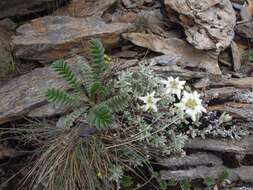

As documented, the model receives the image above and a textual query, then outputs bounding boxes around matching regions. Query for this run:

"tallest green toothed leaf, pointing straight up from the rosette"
[90,38,107,75]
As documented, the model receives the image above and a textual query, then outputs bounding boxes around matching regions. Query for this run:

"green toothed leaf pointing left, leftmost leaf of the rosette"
[46,88,77,105]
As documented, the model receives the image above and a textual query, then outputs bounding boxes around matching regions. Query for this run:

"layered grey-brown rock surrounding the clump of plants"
[0,0,253,190]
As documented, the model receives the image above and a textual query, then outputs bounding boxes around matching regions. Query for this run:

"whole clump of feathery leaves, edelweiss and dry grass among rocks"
[19,39,247,190]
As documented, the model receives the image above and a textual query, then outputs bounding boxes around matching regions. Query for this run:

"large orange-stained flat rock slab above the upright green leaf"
[12,16,133,62]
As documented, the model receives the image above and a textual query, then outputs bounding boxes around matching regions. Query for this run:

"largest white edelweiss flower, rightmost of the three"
[175,91,206,121]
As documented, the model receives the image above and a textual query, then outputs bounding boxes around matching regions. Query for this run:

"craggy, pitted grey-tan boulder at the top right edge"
[164,0,236,50]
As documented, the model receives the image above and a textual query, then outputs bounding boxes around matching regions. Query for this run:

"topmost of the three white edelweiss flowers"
[161,77,185,98]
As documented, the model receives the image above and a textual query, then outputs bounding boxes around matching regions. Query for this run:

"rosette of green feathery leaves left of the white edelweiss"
[46,39,128,130]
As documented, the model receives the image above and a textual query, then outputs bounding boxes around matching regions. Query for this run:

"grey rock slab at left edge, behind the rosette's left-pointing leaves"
[0,56,86,124]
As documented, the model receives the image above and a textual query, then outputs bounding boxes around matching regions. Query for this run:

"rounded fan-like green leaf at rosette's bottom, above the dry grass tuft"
[87,104,113,130]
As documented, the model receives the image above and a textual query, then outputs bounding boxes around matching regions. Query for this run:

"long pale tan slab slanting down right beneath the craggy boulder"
[123,33,221,75]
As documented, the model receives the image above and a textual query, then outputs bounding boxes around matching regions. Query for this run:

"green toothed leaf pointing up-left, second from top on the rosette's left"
[52,60,80,88]
